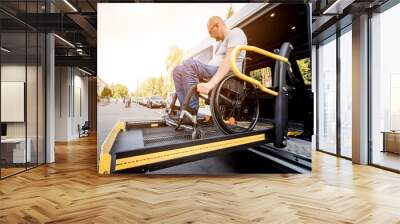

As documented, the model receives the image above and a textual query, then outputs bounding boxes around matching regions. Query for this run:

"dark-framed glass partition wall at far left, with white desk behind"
[0,1,46,178]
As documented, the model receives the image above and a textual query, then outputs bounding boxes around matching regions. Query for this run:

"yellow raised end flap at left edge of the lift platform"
[99,121,125,174]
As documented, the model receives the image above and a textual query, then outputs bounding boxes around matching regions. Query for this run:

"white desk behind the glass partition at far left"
[1,138,32,163]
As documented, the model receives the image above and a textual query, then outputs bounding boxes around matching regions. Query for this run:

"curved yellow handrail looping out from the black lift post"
[231,45,291,96]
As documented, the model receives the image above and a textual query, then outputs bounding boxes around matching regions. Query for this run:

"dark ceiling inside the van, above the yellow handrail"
[242,4,311,72]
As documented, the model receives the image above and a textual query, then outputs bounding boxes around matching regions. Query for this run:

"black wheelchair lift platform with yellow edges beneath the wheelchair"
[99,121,267,174]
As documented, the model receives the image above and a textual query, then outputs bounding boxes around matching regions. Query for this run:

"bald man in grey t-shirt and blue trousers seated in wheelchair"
[172,16,247,116]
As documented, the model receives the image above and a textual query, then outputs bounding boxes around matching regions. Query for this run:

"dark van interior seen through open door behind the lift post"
[238,4,313,140]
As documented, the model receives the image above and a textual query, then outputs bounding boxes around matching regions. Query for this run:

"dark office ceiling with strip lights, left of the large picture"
[0,0,103,74]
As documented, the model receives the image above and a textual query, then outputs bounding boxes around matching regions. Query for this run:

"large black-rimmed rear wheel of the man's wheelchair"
[210,75,259,134]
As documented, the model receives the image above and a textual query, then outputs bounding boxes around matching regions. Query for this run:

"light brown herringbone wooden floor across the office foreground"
[0,134,400,224]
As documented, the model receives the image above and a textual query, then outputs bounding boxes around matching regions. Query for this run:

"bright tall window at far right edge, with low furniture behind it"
[370,4,400,170]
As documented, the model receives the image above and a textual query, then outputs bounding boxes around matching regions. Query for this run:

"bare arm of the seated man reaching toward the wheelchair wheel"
[197,48,233,94]
